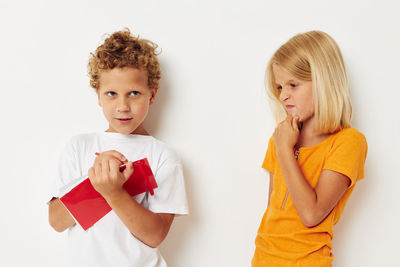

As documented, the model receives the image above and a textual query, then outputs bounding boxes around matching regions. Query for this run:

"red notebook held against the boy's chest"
[60,158,157,231]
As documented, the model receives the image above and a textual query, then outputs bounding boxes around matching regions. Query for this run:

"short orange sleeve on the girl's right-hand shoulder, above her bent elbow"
[323,129,368,188]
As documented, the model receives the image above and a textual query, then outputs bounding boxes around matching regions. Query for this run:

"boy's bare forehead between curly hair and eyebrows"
[100,67,148,86]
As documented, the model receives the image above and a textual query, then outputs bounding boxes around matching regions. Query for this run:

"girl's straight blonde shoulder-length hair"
[265,31,352,133]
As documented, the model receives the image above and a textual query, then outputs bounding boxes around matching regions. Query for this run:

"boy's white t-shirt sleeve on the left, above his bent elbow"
[50,138,82,199]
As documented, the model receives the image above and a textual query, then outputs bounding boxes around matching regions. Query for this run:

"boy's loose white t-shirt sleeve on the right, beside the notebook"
[144,149,189,215]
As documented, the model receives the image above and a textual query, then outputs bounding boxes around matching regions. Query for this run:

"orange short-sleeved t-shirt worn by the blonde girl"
[252,128,367,267]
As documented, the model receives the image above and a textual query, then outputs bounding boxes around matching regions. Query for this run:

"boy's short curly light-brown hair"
[88,28,161,90]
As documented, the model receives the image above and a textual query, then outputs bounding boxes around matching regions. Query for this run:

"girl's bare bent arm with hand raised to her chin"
[273,115,350,227]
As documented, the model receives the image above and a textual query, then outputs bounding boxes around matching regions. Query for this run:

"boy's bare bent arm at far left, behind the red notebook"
[49,198,75,232]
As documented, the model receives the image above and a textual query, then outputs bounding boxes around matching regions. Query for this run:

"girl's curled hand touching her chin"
[272,114,300,155]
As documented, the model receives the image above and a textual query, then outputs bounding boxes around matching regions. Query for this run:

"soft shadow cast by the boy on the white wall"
[145,62,196,266]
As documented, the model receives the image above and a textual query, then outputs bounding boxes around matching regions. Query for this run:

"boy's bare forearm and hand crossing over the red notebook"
[89,152,175,247]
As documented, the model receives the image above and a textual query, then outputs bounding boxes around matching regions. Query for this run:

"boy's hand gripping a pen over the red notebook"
[89,151,133,199]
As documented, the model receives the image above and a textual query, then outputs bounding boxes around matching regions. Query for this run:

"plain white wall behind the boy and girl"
[0,0,400,267]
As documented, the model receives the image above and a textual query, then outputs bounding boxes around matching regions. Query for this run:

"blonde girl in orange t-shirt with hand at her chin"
[252,31,367,267]
